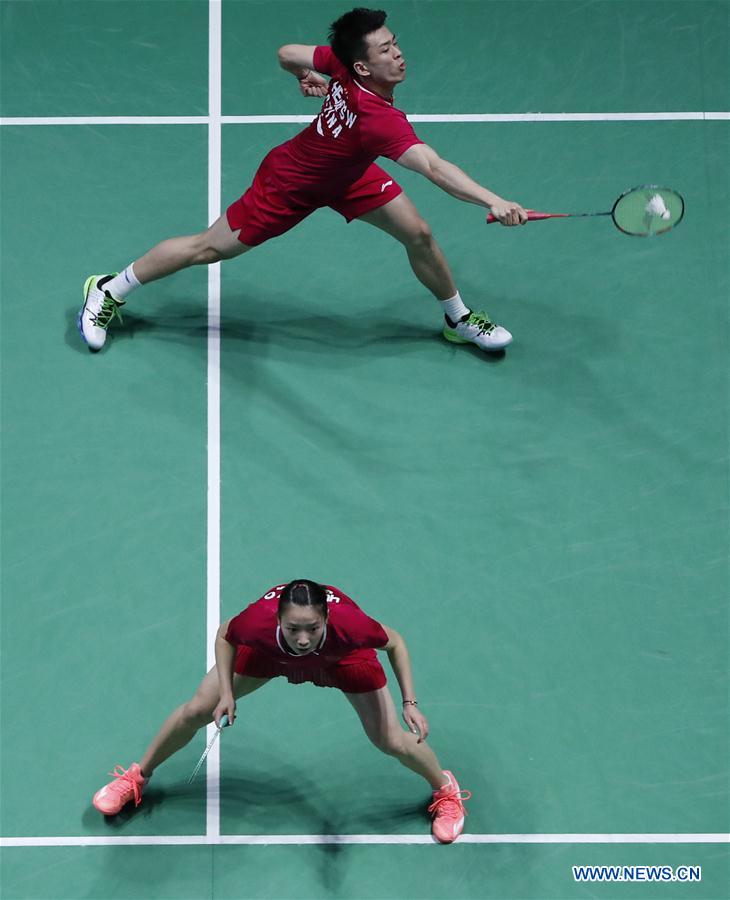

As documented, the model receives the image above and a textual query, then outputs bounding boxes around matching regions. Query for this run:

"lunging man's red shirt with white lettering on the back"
[264,47,423,206]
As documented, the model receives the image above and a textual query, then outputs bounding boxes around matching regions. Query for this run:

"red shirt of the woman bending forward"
[226,584,388,669]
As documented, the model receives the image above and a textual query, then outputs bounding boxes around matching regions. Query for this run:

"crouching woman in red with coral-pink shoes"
[92,579,471,843]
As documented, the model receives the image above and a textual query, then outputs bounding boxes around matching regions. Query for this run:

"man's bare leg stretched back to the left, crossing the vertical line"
[132,215,251,284]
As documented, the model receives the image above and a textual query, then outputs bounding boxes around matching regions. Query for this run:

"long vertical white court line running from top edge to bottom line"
[205,0,221,840]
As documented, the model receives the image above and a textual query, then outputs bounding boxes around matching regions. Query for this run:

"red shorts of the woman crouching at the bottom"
[234,645,388,694]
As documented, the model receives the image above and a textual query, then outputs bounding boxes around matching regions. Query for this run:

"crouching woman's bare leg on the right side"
[345,687,447,791]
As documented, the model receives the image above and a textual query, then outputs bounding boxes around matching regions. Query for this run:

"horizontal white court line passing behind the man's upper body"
[0,111,730,125]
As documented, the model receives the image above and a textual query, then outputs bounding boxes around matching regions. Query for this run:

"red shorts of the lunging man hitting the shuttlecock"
[226,156,403,247]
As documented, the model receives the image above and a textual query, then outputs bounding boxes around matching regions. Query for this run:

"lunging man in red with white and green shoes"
[78,8,527,351]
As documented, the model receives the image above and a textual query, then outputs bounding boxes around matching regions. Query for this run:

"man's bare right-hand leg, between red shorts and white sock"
[356,194,456,300]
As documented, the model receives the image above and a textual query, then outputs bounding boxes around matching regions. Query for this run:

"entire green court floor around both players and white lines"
[0,0,730,900]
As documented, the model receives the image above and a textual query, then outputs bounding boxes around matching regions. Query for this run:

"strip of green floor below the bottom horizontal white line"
[3,844,728,900]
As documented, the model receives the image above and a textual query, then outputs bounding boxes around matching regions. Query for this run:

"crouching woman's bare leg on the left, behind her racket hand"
[140,666,268,778]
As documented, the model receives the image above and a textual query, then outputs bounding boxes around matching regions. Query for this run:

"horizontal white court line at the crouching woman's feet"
[0,832,730,847]
